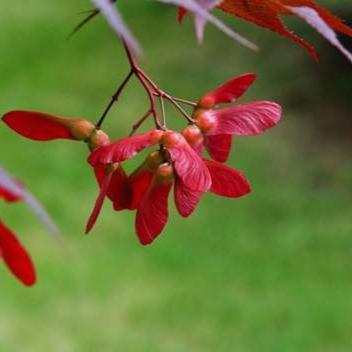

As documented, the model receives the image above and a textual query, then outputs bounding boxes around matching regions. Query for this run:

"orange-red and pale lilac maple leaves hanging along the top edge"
[91,0,352,63]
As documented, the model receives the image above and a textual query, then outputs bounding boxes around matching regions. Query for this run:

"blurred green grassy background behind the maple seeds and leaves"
[0,0,352,352]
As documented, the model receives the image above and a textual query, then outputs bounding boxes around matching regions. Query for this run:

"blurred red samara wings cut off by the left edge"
[0,182,36,286]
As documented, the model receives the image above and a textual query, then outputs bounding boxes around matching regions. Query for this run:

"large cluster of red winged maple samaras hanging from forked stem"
[3,74,281,244]
